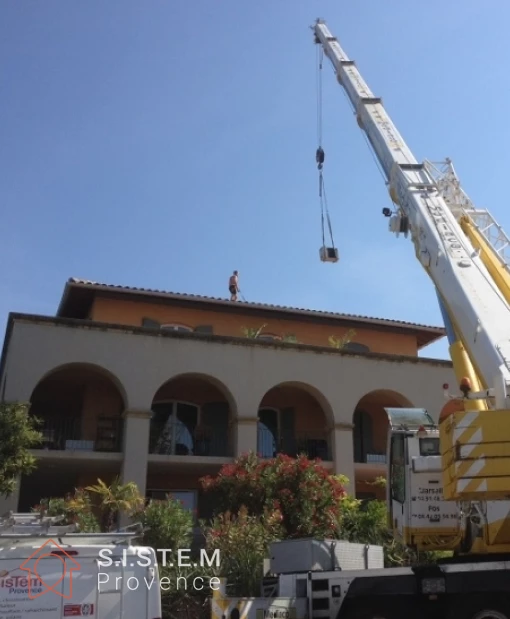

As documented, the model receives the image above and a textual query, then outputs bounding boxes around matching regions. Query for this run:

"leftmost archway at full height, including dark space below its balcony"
[18,363,125,511]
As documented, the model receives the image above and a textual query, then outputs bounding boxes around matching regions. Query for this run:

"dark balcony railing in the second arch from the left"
[149,421,231,457]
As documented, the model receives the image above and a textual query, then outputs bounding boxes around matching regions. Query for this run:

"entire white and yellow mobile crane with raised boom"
[213,20,510,619]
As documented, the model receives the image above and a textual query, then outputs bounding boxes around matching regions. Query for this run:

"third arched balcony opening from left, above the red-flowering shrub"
[257,383,333,460]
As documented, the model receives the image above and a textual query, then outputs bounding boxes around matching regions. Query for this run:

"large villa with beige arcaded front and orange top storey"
[0,279,454,517]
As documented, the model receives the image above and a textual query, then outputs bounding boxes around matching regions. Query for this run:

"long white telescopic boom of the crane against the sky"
[313,20,510,409]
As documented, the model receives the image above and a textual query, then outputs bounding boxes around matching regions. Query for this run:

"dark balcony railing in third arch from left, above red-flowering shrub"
[257,426,331,460]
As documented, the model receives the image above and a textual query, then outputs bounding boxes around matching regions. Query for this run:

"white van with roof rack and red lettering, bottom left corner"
[0,514,161,619]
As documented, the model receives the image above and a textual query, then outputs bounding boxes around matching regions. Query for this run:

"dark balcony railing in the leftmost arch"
[37,417,123,452]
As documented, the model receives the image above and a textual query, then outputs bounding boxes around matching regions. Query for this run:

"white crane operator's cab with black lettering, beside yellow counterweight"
[385,408,461,550]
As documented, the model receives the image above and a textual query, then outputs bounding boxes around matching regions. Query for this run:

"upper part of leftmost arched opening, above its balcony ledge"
[30,364,125,452]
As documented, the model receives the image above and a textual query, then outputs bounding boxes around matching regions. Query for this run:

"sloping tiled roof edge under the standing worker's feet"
[59,277,445,339]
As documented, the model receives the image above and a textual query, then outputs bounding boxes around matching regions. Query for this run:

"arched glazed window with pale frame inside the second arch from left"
[151,402,199,456]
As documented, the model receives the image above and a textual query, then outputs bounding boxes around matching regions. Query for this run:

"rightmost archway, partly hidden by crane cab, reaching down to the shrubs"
[353,389,413,499]
